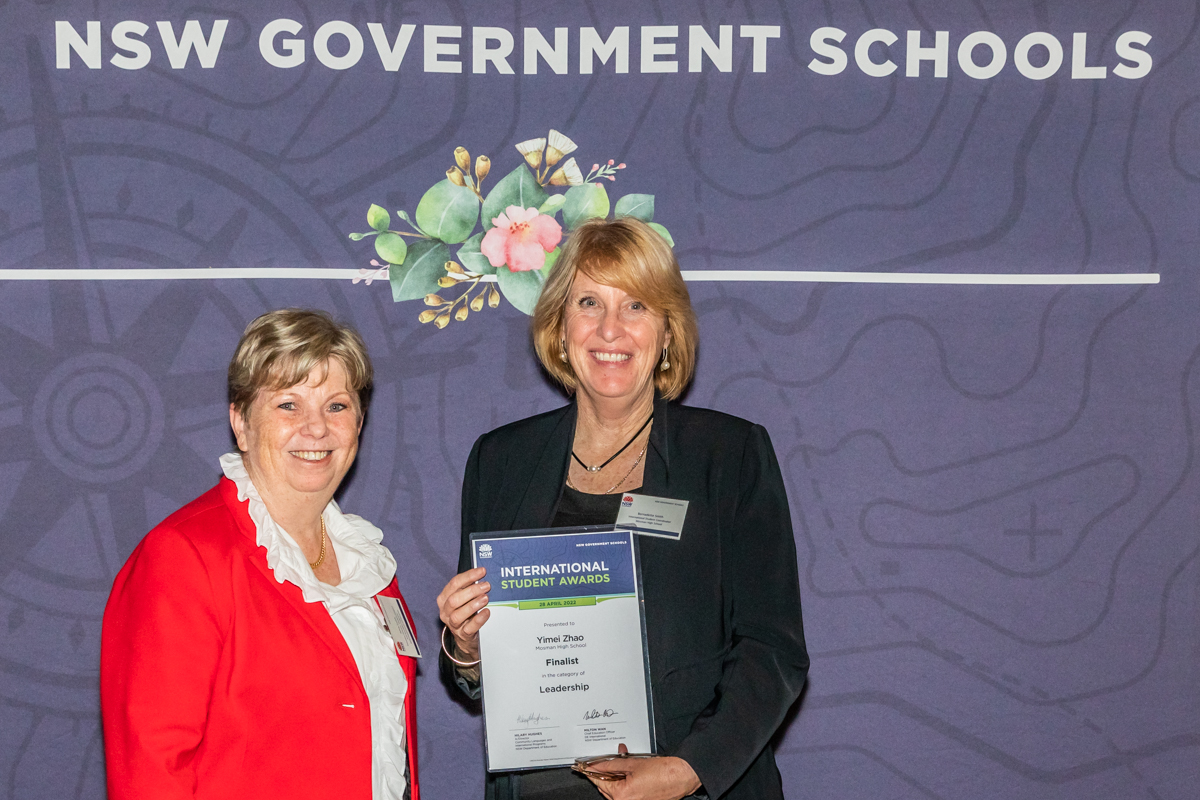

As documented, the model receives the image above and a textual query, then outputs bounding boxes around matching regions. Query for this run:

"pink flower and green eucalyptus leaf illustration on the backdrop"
[350,130,674,329]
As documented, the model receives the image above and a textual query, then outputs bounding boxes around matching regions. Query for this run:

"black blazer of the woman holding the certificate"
[443,398,809,800]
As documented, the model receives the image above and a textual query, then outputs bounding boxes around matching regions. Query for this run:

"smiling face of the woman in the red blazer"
[229,359,362,505]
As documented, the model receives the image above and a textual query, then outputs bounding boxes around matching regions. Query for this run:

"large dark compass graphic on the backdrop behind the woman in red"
[0,31,451,798]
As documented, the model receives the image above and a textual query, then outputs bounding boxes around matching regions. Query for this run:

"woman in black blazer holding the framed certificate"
[438,218,809,800]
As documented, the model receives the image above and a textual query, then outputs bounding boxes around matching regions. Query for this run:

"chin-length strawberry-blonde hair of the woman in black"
[532,217,698,399]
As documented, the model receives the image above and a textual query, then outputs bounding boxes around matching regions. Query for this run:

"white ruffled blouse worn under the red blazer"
[221,453,408,800]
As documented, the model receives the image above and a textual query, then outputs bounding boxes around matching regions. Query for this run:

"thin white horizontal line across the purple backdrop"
[0,266,1159,285]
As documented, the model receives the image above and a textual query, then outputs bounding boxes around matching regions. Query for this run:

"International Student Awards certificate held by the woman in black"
[470,525,654,772]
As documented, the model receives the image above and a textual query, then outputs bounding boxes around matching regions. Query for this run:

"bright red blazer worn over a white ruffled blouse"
[100,479,420,800]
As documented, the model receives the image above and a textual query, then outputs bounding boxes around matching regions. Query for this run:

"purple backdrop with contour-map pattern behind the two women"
[0,0,1200,800]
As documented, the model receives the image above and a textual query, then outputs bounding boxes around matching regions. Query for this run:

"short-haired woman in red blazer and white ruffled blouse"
[100,309,420,800]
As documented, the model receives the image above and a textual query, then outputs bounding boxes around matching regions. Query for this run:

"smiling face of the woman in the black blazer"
[563,272,671,403]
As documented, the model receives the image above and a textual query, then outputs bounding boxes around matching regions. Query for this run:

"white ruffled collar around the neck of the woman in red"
[221,452,396,613]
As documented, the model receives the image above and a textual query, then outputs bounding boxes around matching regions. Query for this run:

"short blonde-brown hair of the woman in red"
[229,308,374,420]
